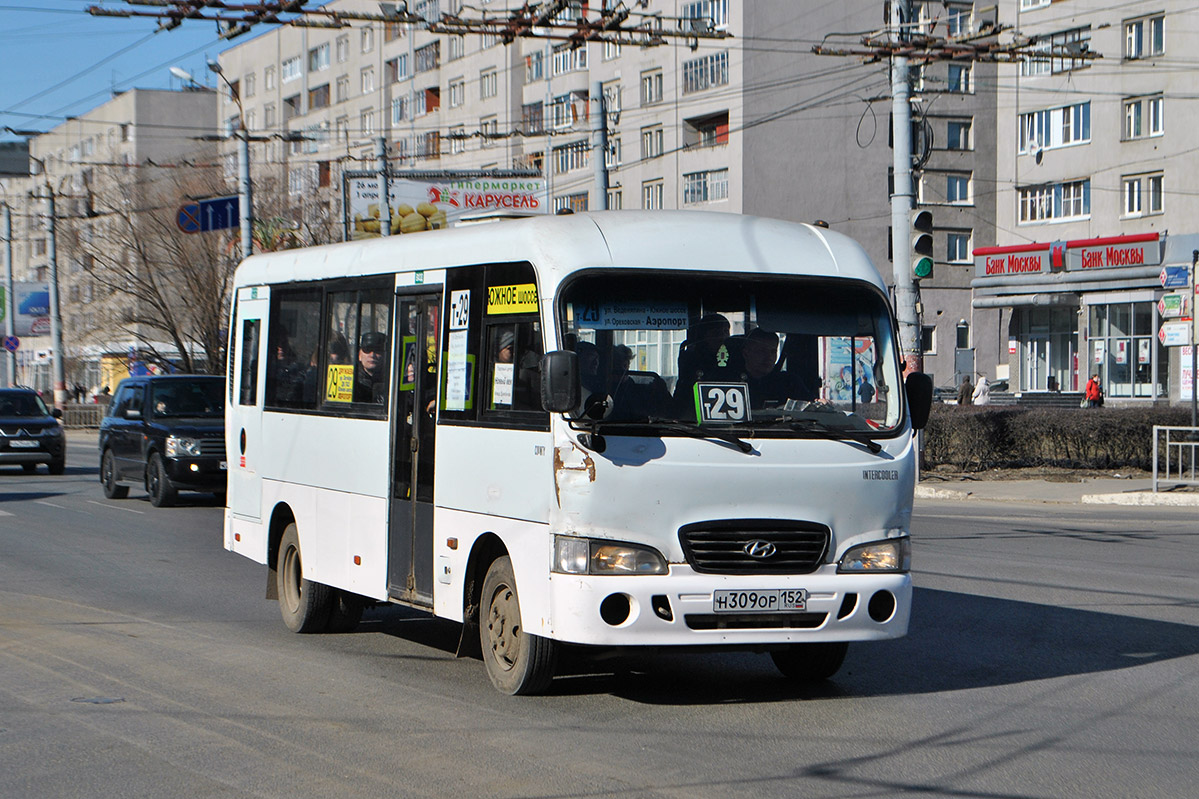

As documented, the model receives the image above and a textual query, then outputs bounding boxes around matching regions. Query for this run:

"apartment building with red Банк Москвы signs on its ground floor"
[972,0,1199,402]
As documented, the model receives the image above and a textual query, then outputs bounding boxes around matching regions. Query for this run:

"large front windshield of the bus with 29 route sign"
[560,271,902,435]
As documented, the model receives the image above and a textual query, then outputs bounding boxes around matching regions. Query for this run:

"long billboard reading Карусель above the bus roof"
[343,174,547,241]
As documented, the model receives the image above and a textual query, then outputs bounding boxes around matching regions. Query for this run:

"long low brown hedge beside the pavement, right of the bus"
[924,404,1191,471]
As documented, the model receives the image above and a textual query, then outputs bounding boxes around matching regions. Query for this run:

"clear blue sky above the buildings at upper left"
[0,0,252,140]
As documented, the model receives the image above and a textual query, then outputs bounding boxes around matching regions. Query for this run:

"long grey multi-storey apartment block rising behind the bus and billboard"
[219,0,1006,384]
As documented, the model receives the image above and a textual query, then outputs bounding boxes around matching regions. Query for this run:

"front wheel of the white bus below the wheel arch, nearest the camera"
[478,555,558,696]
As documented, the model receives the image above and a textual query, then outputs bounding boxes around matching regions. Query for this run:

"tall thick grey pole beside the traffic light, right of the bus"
[887,0,924,373]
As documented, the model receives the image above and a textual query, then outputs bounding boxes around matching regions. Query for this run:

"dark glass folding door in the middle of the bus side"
[387,294,441,607]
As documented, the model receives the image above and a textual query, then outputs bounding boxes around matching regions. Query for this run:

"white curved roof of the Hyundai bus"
[235,211,886,295]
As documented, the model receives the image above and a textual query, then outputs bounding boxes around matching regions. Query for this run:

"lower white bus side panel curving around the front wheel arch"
[433,507,552,636]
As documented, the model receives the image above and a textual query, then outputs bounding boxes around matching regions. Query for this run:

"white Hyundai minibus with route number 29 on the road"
[224,211,932,693]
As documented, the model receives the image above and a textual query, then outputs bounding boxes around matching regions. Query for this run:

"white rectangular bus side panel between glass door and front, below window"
[433,425,555,520]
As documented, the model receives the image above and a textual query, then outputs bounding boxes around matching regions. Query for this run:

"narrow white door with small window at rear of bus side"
[225,286,271,522]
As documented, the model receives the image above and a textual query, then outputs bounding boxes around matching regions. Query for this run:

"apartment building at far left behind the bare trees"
[17,89,217,389]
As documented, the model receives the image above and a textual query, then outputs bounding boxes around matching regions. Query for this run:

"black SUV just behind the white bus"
[100,374,227,507]
